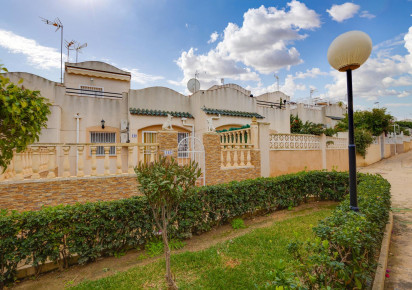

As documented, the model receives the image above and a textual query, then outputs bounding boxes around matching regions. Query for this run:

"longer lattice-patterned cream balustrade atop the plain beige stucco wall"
[269,134,321,150]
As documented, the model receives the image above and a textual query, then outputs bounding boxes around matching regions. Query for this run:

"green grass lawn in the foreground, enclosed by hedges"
[74,206,334,290]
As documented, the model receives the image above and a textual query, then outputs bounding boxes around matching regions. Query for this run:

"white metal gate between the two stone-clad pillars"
[177,137,206,185]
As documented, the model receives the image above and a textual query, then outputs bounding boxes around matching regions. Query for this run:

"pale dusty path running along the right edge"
[359,151,412,289]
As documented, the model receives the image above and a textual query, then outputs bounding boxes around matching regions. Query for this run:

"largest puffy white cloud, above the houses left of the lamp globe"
[176,0,321,88]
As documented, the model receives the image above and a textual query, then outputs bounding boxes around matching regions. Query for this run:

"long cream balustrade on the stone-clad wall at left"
[0,143,158,181]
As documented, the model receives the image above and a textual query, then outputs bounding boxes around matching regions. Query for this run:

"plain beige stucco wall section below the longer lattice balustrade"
[269,150,324,176]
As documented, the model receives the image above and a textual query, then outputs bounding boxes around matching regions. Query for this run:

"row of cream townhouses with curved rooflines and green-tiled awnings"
[7,61,290,147]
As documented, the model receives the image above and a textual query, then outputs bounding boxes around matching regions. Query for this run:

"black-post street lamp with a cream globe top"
[328,31,372,211]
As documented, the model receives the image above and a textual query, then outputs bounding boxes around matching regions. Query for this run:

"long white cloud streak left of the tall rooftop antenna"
[0,29,62,69]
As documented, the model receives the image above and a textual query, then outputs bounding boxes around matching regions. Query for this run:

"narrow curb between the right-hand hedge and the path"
[372,212,393,290]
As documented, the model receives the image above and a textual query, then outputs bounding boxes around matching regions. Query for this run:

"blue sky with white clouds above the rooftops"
[0,0,412,119]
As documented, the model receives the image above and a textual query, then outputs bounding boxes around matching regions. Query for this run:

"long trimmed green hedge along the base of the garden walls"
[0,171,348,286]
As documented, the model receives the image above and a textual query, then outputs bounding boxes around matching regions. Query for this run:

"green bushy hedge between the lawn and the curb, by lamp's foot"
[289,175,391,289]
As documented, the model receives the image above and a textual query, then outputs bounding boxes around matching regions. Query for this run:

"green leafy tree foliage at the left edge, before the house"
[0,65,50,170]
